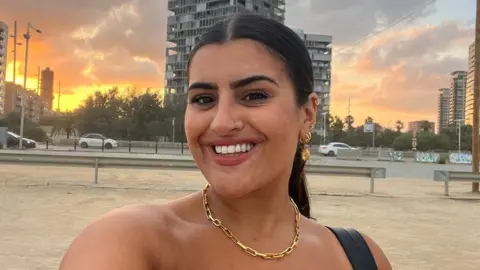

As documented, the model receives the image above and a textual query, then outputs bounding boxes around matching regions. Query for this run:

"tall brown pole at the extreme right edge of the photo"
[472,0,480,193]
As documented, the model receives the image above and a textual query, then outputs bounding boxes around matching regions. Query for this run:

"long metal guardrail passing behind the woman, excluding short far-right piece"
[0,150,386,193]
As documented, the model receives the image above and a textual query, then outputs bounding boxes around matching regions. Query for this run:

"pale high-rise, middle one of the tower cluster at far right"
[448,70,467,125]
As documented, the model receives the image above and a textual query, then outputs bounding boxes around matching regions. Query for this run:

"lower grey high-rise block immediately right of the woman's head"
[295,30,332,135]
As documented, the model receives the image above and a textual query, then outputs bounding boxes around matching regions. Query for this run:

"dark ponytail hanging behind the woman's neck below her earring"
[288,143,312,218]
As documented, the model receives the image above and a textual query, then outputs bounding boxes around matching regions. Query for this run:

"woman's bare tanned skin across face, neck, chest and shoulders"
[60,40,391,270]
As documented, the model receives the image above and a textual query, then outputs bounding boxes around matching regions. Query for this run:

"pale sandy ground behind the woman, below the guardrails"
[0,165,480,270]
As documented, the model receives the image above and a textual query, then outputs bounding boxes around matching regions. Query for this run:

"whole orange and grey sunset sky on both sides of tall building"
[0,0,476,126]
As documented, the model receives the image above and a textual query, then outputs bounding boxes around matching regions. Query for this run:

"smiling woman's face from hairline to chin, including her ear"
[185,40,316,197]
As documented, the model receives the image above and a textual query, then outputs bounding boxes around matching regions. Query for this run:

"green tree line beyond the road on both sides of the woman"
[0,88,472,151]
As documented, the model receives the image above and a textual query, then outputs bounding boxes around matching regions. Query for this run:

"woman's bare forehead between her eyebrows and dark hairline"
[189,39,287,82]
